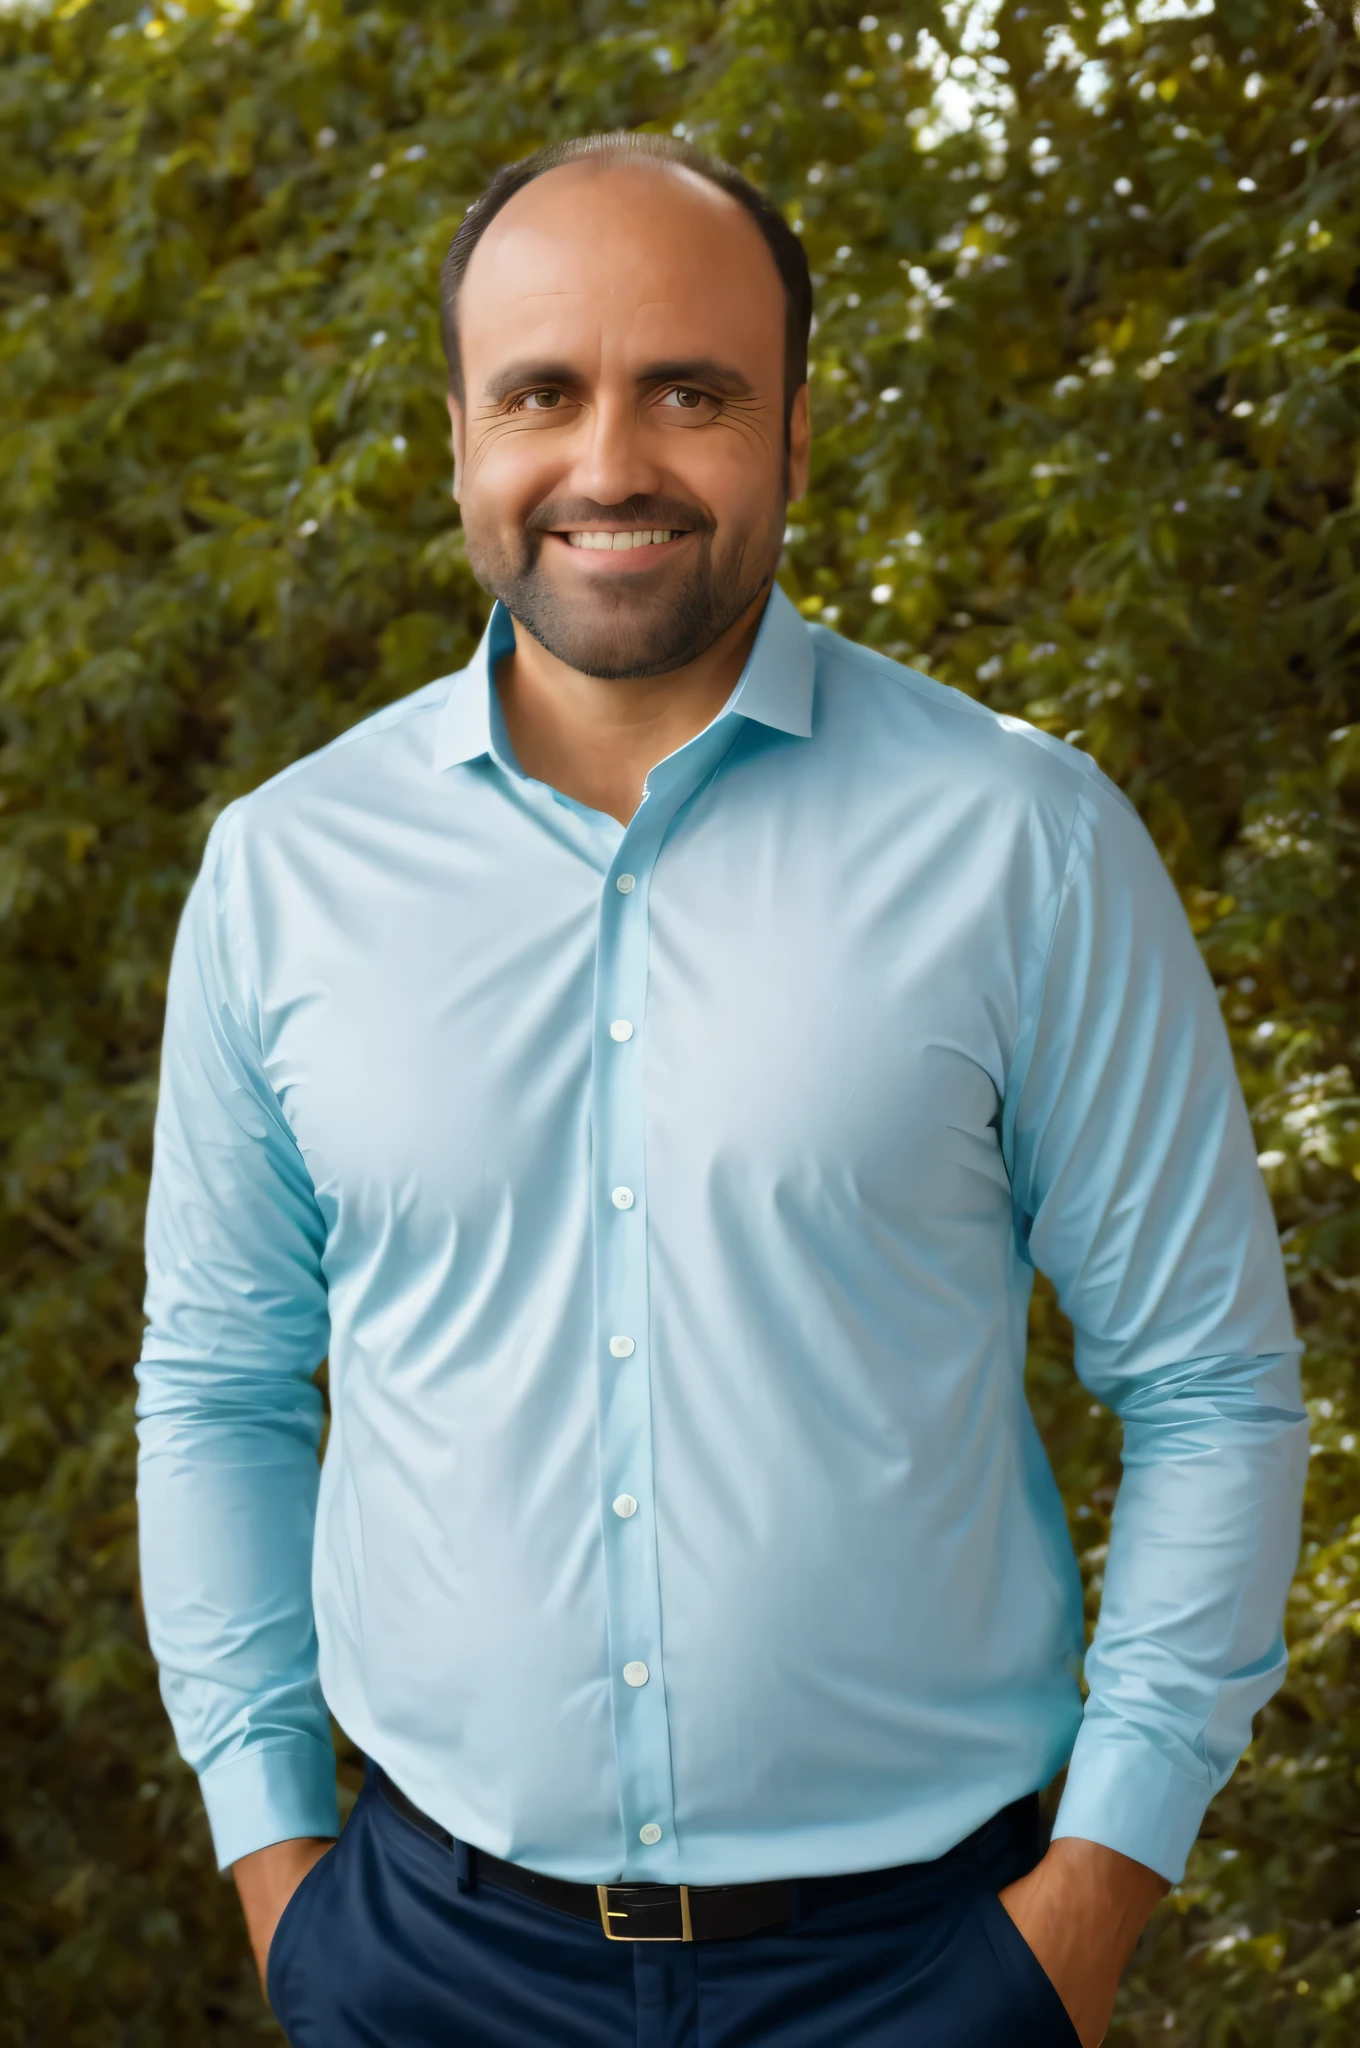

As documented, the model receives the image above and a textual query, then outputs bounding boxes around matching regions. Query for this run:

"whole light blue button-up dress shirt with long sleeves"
[137,592,1305,1884]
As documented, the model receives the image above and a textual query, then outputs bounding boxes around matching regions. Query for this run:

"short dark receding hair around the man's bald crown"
[438,129,813,420]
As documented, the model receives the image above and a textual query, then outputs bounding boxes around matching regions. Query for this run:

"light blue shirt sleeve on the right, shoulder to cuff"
[1004,776,1307,1880]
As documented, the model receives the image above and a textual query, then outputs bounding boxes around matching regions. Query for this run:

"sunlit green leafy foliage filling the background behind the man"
[0,0,1360,2048]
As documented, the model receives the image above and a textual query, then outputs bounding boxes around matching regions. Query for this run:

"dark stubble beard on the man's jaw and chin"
[467,512,776,682]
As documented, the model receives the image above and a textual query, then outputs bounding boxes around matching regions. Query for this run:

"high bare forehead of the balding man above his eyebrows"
[459,162,784,381]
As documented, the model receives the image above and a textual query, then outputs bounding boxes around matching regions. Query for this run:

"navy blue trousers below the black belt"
[268,1774,1077,2048]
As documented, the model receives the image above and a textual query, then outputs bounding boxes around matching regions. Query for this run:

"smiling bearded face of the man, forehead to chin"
[449,164,807,676]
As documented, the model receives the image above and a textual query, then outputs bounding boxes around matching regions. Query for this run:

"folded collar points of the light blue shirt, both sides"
[434,584,817,768]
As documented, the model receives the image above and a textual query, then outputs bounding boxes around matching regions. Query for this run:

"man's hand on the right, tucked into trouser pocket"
[1002,1837,1170,2048]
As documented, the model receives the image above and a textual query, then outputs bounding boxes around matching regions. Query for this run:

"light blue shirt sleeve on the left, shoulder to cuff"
[137,813,336,1868]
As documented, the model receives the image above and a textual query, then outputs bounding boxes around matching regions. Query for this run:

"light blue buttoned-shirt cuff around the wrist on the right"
[1053,1718,1213,1884]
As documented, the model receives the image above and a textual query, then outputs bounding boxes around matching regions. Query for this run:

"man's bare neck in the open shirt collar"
[496,586,770,825]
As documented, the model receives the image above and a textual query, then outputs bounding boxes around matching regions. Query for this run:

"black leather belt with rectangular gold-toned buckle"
[375,1767,1038,1942]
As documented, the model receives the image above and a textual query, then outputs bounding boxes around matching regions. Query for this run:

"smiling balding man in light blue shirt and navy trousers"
[139,137,1305,2048]
